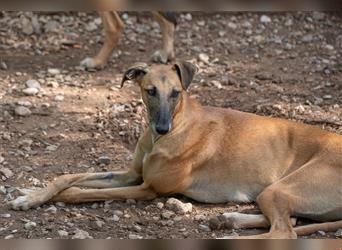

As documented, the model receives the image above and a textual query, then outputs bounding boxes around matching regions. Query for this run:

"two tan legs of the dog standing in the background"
[81,11,177,69]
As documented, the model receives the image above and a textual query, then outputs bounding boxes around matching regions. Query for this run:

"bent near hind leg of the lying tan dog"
[231,160,342,238]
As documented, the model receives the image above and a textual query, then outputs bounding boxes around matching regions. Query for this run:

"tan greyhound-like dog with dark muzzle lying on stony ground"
[10,62,342,238]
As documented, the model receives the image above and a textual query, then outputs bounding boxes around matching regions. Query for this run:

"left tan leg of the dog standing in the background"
[81,11,124,68]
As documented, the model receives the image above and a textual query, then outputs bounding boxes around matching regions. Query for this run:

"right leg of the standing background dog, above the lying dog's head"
[152,12,176,63]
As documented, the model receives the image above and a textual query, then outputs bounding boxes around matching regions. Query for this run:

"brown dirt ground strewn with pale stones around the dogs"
[0,12,342,239]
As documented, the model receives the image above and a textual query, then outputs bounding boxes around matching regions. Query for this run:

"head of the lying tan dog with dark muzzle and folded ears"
[121,62,197,135]
